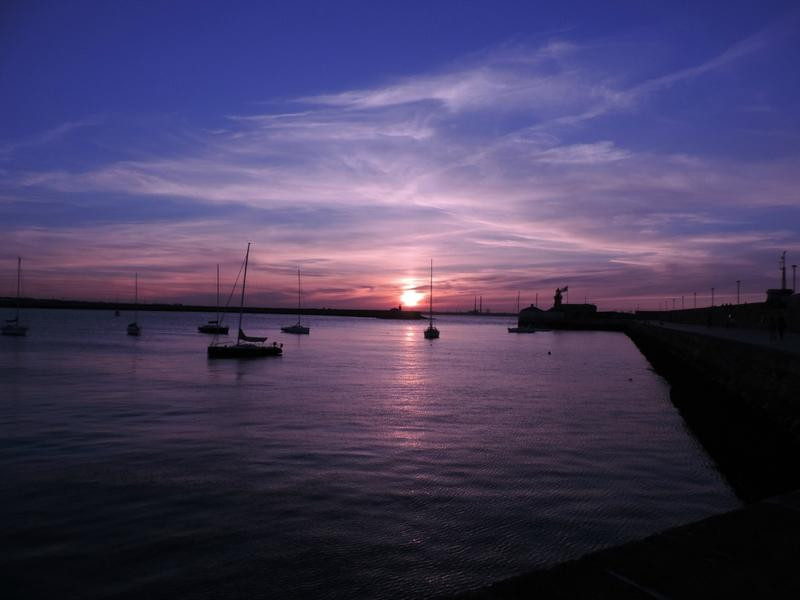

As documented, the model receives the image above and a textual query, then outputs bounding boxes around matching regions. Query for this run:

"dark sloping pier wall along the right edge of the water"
[625,322,800,502]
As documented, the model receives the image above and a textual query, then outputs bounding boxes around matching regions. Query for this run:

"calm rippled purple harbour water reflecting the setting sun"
[0,310,739,598]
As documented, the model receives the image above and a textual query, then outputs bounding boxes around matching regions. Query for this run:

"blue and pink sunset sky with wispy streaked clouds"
[0,0,800,312]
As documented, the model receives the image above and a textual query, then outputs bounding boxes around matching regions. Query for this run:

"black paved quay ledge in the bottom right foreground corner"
[457,491,800,600]
